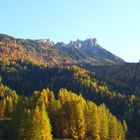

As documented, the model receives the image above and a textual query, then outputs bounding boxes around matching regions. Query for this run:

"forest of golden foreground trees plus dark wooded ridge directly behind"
[0,62,140,140]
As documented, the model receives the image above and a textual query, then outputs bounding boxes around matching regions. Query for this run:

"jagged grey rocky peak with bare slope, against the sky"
[54,38,124,65]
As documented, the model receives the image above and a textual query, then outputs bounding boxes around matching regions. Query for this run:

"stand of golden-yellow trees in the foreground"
[0,84,127,140]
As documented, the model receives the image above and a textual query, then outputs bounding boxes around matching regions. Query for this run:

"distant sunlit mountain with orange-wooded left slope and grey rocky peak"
[0,34,124,66]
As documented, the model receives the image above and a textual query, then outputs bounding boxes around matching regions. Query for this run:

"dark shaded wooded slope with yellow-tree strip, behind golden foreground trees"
[0,62,140,140]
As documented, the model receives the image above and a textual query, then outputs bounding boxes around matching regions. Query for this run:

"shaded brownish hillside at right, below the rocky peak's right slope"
[92,63,140,97]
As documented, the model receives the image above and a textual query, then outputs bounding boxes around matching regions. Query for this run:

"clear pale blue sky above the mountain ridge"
[0,0,140,62]
